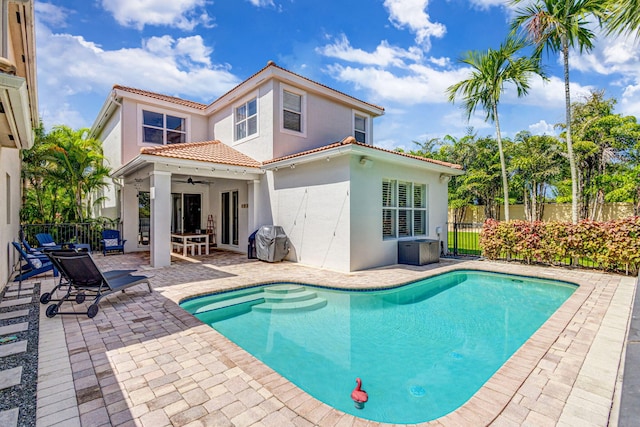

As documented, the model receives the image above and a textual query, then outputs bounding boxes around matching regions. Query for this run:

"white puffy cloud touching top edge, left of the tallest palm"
[384,0,447,50]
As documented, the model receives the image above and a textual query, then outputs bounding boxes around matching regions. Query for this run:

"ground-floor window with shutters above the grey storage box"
[380,178,429,240]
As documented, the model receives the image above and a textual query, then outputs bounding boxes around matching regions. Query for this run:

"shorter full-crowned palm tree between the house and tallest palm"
[447,37,543,221]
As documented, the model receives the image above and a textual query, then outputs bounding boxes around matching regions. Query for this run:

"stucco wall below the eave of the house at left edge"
[0,147,22,290]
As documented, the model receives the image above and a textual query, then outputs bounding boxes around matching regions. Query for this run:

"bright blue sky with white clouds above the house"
[35,0,640,150]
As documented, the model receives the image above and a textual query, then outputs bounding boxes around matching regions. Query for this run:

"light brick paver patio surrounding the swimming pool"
[31,251,635,427]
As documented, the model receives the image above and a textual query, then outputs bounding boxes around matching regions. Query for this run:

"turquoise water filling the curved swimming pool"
[181,271,577,424]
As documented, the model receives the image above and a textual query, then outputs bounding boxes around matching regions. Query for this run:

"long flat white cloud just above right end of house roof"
[316,34,422,67]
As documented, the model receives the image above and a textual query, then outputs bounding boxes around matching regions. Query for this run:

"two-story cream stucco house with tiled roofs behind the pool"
[92,61,462,271]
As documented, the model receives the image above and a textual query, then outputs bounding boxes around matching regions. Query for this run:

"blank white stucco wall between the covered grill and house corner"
[271,157,351,271]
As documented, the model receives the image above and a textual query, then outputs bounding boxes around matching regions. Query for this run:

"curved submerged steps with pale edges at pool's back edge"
[252,284,327,311]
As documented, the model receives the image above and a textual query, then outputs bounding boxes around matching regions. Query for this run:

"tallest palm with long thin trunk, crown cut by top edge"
[512,0,604,223]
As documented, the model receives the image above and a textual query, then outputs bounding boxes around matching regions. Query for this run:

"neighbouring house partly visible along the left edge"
[0,0,39,290]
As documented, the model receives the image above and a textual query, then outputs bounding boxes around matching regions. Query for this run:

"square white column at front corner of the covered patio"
[149,171,171,267]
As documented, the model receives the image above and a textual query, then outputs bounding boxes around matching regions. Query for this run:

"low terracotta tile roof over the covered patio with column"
[140,140,261,168]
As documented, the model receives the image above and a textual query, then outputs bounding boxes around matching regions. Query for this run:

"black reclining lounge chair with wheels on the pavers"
[46,251,151,318]
